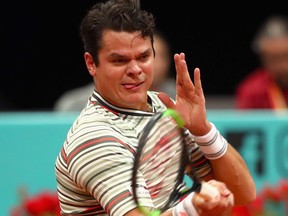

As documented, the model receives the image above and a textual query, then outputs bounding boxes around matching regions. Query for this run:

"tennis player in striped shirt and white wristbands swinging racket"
[55,0,256,216]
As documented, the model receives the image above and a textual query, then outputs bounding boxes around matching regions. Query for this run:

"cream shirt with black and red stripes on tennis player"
[55,91,211,216]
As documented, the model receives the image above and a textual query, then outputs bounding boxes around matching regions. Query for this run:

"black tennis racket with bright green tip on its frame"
[132,109,219,216]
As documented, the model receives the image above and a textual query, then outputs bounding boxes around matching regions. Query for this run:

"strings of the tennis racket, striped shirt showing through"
[140,120,184,206]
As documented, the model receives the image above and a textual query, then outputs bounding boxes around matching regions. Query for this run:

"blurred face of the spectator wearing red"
[260,37,288,88]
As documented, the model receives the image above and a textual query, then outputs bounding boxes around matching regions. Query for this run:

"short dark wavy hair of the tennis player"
[80,0,155,66]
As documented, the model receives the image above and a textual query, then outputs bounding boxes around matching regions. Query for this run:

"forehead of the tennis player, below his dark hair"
[102,30,151,51]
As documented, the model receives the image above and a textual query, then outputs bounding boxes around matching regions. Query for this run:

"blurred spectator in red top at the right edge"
[235,16,288,110]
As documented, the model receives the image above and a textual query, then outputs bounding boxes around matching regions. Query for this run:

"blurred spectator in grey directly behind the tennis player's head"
[54,31,176,111]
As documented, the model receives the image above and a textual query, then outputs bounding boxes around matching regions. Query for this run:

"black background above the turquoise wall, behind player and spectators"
[0,0,287,111]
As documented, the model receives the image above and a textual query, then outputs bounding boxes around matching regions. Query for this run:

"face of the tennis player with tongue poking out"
[94,31,154,110]
